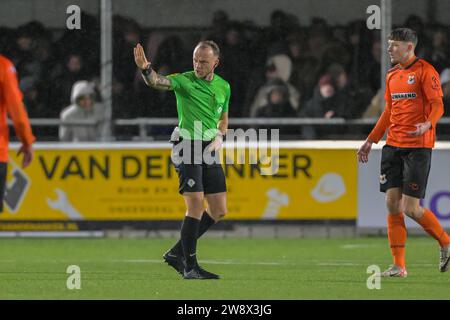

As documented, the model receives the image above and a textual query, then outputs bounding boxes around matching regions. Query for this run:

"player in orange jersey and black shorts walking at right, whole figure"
[358,28,450,277]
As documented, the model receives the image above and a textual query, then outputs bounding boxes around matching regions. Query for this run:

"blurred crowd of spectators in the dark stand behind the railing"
[0,10,450,138]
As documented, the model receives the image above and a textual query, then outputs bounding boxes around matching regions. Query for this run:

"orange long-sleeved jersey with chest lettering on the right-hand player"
[369,57,443,148]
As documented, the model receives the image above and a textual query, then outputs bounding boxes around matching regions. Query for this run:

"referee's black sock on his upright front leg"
[181,216,200,270]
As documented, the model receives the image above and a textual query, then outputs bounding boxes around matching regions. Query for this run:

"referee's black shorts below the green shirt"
[172,140,227,194]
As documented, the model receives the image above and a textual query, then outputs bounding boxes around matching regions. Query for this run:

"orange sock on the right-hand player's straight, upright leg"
[387,213,407,268]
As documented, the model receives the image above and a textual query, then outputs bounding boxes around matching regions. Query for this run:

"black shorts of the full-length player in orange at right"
[380,145,431,199]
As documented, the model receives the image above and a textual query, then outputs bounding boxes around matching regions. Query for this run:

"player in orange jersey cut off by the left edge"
[0,54,35,212]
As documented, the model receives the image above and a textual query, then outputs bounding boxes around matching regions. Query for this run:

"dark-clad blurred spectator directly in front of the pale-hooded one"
[256,82,296,118]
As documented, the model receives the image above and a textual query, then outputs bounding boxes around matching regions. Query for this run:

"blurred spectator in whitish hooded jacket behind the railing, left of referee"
[59,81,107,142]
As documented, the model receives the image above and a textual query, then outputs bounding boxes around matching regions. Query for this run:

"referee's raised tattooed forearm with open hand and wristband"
[134,43,172,90]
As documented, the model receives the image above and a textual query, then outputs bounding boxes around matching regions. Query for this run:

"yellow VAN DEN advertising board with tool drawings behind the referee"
[0,144,357,226]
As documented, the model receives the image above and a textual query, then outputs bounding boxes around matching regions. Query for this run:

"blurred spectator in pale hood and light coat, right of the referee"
[250,54,300,117]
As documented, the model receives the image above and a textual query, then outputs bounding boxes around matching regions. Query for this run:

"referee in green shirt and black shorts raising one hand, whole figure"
[134,41,231,279]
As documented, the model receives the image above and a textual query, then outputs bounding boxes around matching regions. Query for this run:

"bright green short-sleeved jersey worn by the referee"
[168,71,231,140]
